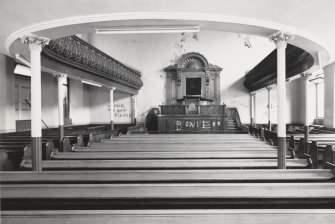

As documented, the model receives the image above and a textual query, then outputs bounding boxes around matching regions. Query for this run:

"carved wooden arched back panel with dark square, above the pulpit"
[164,52,222,105]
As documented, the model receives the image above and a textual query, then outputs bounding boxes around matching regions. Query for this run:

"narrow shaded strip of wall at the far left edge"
[0,54,16,133]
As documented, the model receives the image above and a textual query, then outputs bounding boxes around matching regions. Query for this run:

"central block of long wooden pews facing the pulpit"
[0,134,335,224]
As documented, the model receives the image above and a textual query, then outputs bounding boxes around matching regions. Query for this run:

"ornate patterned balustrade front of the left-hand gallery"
[43,36,143,89]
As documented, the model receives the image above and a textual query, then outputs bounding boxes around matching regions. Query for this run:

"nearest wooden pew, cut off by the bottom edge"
[1,209,335,224]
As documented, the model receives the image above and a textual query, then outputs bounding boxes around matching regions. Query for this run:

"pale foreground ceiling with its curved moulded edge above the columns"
[0,0,335,66]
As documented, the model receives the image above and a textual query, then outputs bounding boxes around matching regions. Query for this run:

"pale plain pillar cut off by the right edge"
[323,62,335,128]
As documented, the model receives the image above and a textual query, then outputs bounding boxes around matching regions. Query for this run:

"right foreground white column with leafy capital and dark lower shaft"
[270,31,294,169]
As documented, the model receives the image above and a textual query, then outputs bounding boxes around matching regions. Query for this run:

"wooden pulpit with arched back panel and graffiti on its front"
[158,53,226,133]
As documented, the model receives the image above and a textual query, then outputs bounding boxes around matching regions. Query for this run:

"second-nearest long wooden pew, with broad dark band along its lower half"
[1,182,335,210]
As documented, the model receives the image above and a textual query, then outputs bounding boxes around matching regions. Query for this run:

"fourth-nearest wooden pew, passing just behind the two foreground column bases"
[21,159,309,170]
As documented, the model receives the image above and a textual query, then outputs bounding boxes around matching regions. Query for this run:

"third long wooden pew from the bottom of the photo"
[0,169,335,184]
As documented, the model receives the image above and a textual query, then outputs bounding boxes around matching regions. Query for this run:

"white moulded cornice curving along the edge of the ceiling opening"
[4,11,326,61]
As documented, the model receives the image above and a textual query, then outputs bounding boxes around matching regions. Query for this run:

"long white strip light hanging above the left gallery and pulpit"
[96,25,200,34]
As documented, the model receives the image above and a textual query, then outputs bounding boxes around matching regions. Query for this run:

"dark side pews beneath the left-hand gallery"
[0,125,118,170]
